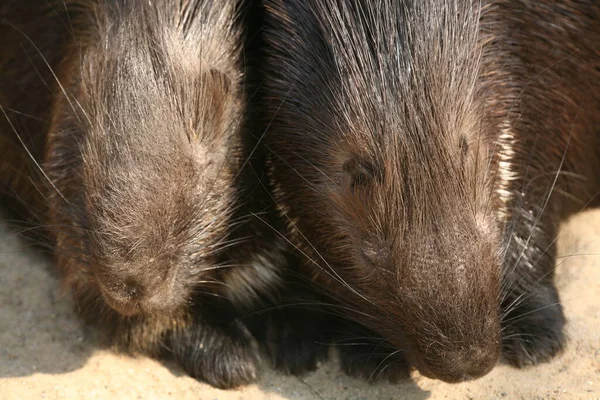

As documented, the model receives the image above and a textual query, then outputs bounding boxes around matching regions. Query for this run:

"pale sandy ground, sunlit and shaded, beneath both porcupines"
[0,211,600,400]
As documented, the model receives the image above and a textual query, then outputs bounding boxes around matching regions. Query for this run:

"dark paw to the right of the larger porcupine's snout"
[502,286,566,368]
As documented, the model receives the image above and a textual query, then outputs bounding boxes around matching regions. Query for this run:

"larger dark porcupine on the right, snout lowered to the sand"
[263,0,600,382]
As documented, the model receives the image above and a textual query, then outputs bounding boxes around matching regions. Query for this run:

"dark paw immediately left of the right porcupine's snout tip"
[338,343,410,383]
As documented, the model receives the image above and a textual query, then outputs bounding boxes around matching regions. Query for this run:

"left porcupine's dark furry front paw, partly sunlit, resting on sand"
[171,322,260,389]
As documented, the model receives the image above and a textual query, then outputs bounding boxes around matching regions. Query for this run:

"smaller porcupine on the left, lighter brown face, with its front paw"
[0,0,284,388]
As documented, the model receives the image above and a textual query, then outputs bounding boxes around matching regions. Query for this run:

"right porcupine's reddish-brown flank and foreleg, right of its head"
[481,0,600,367]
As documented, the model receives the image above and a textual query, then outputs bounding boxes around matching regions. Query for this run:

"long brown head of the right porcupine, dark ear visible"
[267,0,500,382]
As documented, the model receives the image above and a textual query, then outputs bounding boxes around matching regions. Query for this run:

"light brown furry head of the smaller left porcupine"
[45,0,240,316]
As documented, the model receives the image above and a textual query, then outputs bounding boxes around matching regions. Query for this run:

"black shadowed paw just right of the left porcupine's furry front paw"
[265,310,329,375]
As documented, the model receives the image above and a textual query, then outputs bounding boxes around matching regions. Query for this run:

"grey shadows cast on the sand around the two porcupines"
[0,211,429,400]
